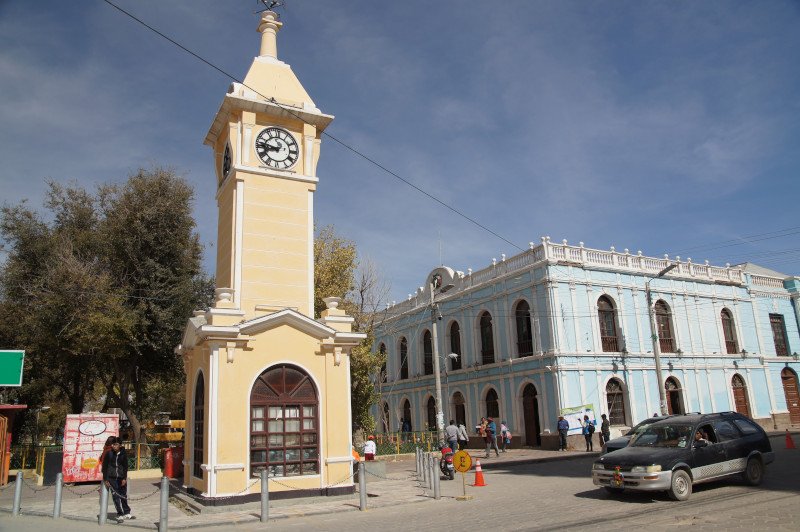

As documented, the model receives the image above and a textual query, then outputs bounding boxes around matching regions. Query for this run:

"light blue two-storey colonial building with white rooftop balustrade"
[374,237,800,448]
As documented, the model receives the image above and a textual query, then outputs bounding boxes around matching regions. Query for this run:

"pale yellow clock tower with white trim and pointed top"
[176,10,365,500]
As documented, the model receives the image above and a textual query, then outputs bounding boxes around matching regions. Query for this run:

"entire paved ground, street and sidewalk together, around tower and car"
[0,435,800,532]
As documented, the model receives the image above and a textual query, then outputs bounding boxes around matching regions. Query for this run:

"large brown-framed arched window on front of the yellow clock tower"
[250,364,319,477]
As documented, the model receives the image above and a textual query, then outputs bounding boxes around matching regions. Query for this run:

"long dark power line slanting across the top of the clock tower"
[103,0,524,251]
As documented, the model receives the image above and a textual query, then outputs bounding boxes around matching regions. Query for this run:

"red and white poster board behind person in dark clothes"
[61,412,119,482]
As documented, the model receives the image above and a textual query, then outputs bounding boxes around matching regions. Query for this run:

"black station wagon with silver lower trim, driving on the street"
[592,412,775,501]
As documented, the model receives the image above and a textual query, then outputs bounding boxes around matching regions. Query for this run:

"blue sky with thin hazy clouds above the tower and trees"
[0,0,800,301]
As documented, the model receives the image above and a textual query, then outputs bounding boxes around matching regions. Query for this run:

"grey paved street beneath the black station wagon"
[0,437,800,532]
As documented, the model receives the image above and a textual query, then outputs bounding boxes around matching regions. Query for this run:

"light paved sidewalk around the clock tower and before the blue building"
[0,449,597,530]
